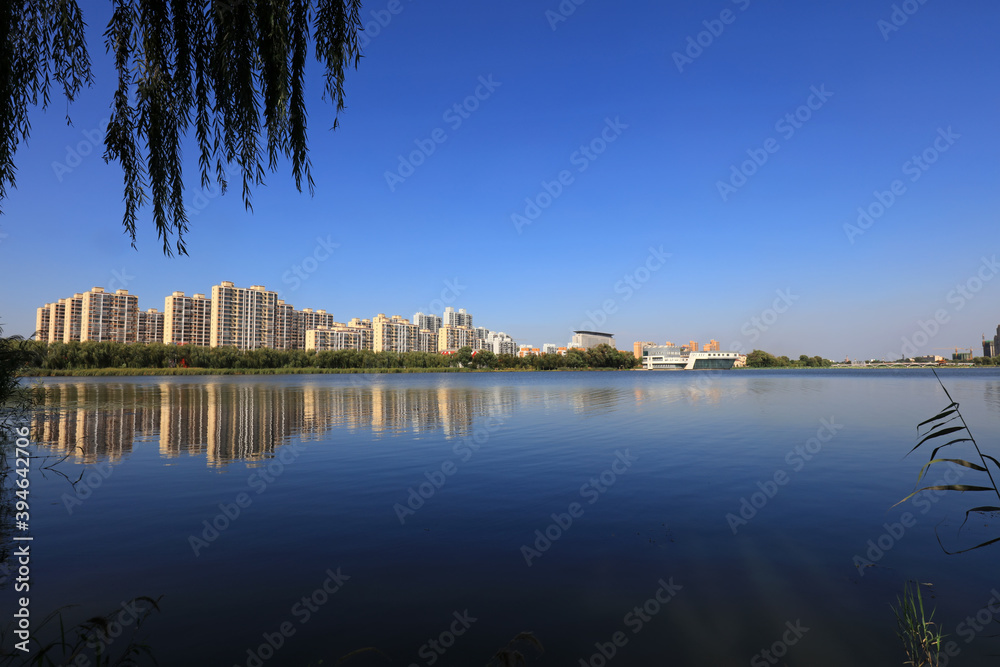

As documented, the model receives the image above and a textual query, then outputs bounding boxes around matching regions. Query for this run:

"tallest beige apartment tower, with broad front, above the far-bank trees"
[209,281,278,350]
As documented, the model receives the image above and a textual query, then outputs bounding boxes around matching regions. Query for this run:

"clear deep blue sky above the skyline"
[0,0,1000,359]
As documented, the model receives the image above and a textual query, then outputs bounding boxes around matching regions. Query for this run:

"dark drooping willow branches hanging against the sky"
[0,0,362,255]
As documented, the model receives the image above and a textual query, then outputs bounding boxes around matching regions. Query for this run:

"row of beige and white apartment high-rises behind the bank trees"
[32,280,524,354]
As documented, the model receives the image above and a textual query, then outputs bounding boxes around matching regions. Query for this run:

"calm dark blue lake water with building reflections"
[2,370,1000,666]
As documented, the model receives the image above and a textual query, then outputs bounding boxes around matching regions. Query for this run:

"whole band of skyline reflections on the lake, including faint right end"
[32,373,755,466]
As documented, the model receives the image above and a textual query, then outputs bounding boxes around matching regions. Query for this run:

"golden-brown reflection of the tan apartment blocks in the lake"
[32,381,517,466]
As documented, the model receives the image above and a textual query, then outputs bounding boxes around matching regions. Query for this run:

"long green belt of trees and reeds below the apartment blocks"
[15,341,639,375]
